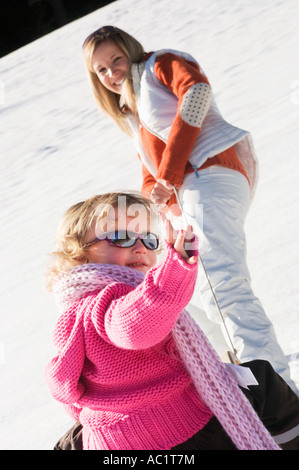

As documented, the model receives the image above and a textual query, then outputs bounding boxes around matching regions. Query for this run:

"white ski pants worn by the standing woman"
[173,166,293,385]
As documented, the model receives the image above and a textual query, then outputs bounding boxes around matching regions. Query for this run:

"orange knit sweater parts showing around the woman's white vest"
[140,53,248,206]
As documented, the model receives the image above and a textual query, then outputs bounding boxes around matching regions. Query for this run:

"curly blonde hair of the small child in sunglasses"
[45,192,157,291]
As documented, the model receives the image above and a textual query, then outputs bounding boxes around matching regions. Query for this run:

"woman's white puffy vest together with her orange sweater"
[128,49,257,202]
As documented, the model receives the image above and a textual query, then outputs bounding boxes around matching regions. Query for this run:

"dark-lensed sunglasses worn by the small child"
[83,230,159,250]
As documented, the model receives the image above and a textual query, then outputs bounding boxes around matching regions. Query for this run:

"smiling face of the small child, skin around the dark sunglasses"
[84,211,157,273]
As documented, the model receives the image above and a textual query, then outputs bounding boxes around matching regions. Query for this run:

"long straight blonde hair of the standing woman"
[83,26,145,135]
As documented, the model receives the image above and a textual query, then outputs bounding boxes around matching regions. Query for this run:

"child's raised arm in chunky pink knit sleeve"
[92,244,197,349]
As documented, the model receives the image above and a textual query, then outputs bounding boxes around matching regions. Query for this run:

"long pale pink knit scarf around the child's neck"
[54,264,280,450]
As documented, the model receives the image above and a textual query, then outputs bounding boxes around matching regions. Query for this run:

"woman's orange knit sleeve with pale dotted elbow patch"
[155,53,211,186]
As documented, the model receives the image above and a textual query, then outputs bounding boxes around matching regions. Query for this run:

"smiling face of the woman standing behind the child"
[92,39,129,95]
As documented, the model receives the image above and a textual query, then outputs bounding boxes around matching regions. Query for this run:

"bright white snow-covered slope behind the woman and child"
[0,0,299,450]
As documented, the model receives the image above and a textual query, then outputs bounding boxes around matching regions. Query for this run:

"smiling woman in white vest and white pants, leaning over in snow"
[83,26,294,386]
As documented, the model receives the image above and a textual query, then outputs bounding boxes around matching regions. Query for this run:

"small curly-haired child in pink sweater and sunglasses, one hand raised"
[46,193,299,450]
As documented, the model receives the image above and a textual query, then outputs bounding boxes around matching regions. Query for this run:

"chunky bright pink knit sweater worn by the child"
[46,246,212,450]
